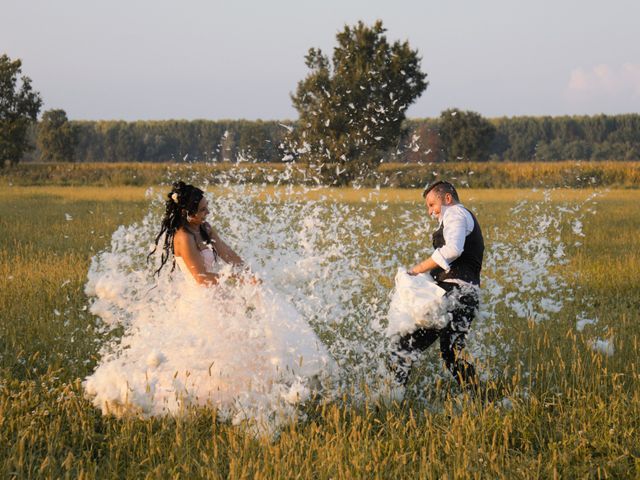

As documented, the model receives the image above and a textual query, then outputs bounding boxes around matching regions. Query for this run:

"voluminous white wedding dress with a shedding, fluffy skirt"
[84,249,337,422]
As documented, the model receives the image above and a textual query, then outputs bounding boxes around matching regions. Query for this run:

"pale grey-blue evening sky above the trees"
[0,0,640,120]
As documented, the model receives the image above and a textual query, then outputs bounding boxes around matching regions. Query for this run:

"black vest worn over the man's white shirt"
[431,207,484,285]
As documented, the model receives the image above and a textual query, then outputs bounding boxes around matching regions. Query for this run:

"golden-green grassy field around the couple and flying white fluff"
[0,186,640,479]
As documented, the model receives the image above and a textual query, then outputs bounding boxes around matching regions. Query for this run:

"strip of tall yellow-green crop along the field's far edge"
[0,161,640,188]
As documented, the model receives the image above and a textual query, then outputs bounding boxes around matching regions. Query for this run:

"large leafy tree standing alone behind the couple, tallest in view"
[291,20,427,184]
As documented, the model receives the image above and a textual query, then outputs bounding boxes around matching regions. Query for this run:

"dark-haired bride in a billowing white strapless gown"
[84,182,336,422]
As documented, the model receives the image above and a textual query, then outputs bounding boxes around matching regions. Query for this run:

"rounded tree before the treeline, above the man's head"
[440,108,496,162]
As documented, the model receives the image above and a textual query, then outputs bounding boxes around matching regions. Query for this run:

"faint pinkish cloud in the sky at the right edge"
[567,63,640,100]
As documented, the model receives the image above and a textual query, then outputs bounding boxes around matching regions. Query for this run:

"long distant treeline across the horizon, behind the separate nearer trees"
[25,114,640,163]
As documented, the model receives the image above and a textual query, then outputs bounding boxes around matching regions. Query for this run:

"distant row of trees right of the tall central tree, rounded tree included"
[398,113,640,162]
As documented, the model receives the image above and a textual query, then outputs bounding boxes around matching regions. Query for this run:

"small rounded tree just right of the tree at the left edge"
[36,110,78,162]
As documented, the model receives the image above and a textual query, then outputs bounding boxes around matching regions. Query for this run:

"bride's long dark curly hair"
[147,181,215,274]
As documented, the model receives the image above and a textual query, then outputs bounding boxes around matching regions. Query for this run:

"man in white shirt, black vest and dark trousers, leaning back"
[392,181,484,388]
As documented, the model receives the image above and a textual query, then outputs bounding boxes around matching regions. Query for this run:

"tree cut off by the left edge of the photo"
[0,55,42,167]
